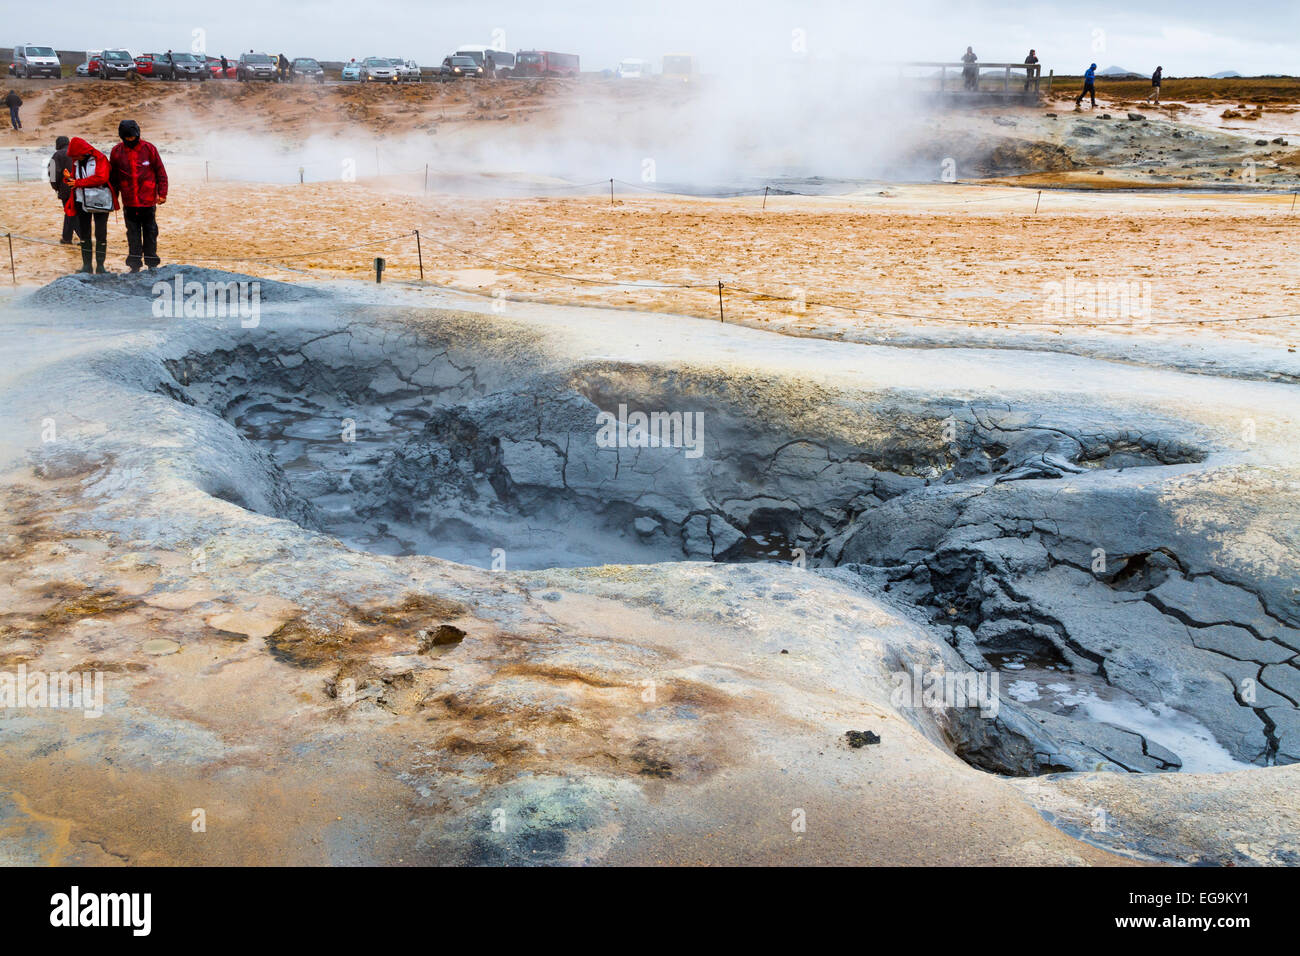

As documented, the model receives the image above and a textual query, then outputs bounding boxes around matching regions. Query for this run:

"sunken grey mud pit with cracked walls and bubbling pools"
[142,310,1300,775]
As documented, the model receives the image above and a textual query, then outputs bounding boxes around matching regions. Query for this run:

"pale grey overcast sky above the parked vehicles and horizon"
[4,0,1300,75]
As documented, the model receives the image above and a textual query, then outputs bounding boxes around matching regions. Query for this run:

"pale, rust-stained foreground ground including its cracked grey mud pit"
[0,267,1300,864]
